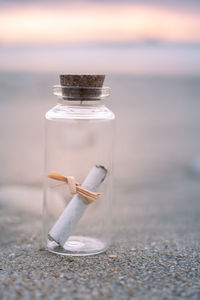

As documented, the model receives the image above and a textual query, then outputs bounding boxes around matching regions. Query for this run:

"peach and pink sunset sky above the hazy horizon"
[0,1,200,44]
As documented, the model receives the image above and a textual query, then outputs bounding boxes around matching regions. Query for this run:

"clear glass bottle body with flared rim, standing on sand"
[43,86,115,255]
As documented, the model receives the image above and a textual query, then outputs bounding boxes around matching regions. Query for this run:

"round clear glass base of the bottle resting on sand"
[46,236,107,256]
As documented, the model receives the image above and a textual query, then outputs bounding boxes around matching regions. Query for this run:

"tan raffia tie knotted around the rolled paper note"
[48,172,101,204]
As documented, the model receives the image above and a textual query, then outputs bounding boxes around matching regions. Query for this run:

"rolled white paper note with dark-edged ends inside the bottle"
[48,166,107,247]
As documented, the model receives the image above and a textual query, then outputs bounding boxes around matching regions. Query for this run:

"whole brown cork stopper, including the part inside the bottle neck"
[60,74,108,101]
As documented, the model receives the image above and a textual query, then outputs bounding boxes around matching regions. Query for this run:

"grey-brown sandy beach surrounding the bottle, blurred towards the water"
[0,73,200,300]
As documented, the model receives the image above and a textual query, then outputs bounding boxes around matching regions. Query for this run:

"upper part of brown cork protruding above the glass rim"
[60,74,105,88]
